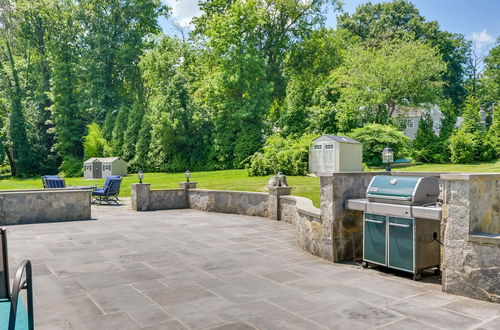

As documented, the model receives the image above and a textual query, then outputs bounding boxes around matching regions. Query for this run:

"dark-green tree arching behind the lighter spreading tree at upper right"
[337,0,470,107]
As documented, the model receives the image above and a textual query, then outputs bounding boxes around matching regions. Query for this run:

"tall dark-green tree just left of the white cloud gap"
[78,0,166,135]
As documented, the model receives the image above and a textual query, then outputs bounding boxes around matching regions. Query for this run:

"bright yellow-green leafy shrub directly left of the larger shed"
[247,133,316,176]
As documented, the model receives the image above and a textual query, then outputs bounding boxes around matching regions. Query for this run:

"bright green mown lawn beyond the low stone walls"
[0,160,500,207]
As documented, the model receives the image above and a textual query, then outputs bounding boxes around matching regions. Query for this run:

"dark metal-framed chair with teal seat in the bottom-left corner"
[0,228,35,330]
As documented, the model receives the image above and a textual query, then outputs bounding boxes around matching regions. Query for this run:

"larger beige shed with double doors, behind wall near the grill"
[309,134,363,173]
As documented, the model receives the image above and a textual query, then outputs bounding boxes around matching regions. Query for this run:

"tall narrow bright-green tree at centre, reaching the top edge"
[201,0,272,168]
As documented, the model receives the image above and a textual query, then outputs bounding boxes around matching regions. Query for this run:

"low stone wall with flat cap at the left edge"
[0,189,91,225]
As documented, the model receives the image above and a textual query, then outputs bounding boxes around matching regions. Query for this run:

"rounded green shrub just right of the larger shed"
[348,124,410,166]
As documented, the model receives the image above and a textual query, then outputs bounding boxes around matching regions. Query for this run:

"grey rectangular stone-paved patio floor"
[4,202,500,330]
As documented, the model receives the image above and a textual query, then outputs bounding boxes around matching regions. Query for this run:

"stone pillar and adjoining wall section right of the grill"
[441,173,500,303]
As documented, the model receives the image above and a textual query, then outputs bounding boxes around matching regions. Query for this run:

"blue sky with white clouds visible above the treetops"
[162,0,500,48]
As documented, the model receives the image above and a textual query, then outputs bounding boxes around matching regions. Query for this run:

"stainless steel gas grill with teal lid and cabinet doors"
[346,175,441,280]
